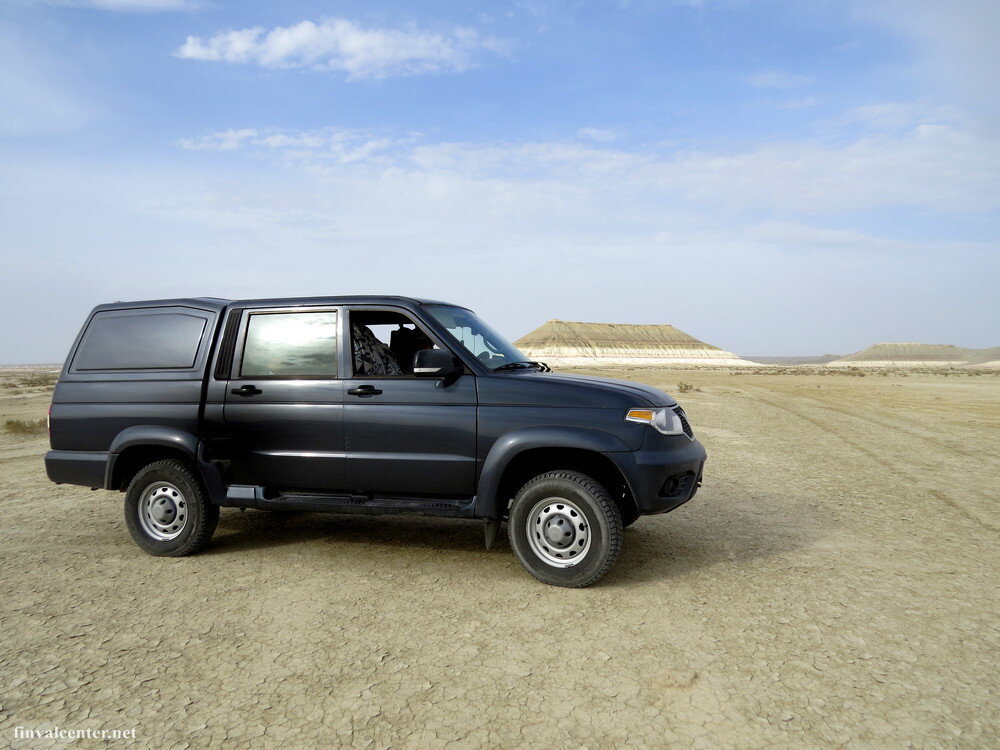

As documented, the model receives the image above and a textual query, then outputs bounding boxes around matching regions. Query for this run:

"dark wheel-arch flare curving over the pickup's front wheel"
[476,426,631,518]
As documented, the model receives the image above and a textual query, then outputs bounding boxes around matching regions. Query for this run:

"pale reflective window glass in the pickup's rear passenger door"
[240,312,337,380]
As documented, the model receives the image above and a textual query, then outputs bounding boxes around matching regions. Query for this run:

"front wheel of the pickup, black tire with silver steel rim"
[507,471,623,588]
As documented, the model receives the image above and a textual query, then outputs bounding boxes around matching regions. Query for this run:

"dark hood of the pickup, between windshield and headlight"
[479,370,677,409]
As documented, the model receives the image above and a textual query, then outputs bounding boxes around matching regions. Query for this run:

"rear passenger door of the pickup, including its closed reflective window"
[224,307,346,493]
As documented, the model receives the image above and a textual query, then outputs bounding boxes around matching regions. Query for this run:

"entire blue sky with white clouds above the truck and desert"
[0,0,1000,363]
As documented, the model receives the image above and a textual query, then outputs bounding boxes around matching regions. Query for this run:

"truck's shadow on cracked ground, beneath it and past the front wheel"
[202,488,837,587]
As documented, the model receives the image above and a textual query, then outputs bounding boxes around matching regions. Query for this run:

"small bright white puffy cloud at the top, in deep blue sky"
[175,18,506,79]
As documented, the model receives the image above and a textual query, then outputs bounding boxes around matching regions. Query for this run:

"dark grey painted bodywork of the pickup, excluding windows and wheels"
[46,297,705,518]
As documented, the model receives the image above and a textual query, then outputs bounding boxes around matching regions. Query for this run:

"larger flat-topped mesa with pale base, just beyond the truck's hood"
[514,320,757,367]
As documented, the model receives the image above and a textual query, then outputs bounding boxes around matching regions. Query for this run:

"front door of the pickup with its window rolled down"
[343,307,477,498]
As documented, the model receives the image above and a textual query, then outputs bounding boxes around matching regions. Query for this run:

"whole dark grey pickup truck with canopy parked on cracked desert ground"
[45,296,705,587]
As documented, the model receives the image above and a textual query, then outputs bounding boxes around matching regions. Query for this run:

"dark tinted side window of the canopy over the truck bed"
[73,310,207,370]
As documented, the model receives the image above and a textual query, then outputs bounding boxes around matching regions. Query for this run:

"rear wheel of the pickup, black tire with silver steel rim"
[125,459,219,557]
